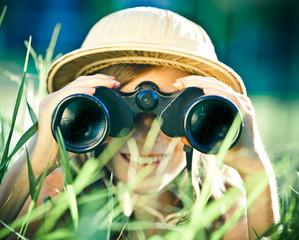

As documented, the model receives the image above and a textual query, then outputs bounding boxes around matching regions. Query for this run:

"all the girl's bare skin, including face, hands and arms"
[0,68,279,239]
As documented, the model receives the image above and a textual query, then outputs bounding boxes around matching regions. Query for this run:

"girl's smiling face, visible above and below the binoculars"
[107,69,189,193]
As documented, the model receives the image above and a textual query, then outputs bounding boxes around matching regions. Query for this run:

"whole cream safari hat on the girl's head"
[47,7,246,94]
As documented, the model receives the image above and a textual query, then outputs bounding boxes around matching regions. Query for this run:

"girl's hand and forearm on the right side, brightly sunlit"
[174,75,280,239]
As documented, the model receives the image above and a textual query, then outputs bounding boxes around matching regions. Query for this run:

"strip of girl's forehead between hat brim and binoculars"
[121,67,190,92]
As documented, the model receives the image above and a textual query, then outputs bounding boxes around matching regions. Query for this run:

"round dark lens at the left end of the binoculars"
[54,96,109,153]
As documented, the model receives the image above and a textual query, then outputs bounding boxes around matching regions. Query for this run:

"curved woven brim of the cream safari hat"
[47,42,246,95]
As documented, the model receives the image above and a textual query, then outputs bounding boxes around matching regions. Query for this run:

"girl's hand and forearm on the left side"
[0,74,119,226]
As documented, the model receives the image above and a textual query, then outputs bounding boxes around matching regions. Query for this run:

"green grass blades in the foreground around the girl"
[0,6,299,240]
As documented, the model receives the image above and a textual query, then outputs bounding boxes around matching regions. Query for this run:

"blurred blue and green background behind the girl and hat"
[0,0,299,161]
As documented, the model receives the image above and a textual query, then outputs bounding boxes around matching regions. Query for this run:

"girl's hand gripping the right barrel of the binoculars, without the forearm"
[173,75,264,176]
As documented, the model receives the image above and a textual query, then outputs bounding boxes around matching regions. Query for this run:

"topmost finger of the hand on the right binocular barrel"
[173,75,232,90]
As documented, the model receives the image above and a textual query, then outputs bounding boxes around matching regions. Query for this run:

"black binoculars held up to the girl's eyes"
[51,81,243,154]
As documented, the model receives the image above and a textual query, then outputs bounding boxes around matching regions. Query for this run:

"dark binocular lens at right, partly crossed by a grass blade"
[185,96,239,153]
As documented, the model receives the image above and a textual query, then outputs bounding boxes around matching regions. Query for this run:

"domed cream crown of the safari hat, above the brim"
[81,7,217,61]
